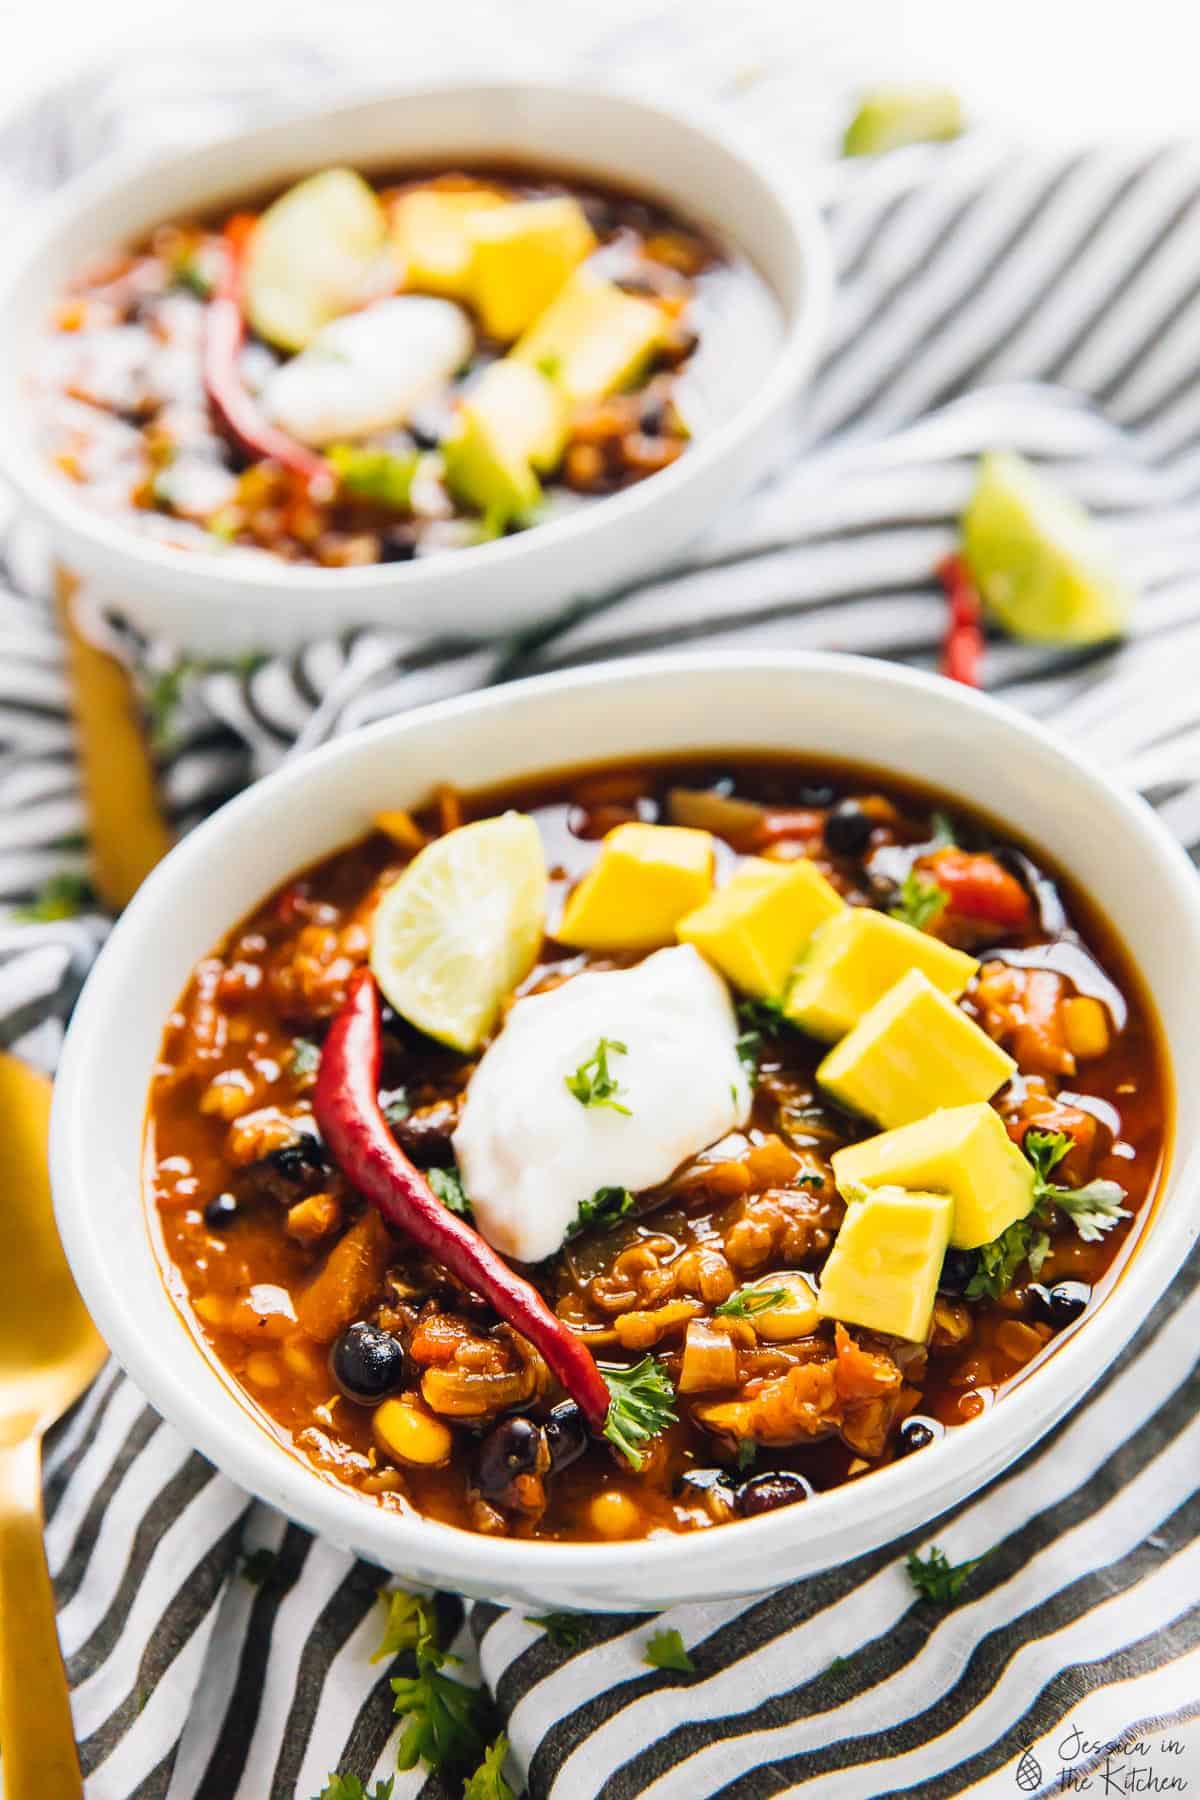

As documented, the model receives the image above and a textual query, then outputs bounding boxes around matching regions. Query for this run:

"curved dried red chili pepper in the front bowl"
[313,968,610,1433]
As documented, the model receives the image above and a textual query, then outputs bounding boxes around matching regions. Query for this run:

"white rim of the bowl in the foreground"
[50,652,1200,1591]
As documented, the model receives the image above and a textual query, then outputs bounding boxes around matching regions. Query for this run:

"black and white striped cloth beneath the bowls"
[0,31,1200,1800]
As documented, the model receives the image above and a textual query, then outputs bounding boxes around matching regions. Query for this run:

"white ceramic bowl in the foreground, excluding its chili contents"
[52,655,1200,1609]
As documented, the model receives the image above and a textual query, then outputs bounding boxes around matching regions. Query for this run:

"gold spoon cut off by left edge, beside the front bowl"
[0,1051,106,1800]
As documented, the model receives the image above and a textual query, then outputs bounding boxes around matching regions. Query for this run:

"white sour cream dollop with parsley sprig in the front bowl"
[453,943,750,1262]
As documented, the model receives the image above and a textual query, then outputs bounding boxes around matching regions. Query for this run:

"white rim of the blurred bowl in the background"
[0,74,833,601]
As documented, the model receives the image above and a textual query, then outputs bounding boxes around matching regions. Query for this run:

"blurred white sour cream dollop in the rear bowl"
[261,293,475,445]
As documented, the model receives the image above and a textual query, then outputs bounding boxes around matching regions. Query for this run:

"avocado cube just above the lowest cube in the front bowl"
[833,1100,1033,1249]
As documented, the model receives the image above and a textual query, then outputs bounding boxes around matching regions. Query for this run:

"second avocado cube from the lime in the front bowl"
[676,857,846,999]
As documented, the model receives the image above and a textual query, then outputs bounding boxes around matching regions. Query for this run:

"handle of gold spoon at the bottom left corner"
[0,1438,83,1800]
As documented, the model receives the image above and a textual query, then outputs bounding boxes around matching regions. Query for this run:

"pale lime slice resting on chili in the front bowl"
[371,812,545,1051]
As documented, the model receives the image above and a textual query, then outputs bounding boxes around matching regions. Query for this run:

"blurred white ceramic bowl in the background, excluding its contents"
[0,81,831,655]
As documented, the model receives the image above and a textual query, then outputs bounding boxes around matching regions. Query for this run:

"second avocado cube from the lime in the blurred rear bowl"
[470,196,596,344]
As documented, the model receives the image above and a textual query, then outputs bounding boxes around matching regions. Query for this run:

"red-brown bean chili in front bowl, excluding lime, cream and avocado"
[148,756,1168,1541]
